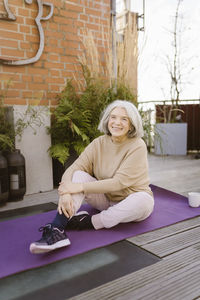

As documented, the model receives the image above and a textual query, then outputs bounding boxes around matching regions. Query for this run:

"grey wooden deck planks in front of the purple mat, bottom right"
[70,217,200,300]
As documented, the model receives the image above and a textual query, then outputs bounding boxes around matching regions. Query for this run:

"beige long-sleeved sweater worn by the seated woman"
[62,135,152,201]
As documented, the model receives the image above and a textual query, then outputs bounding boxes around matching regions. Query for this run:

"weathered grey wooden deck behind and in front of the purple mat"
[70,156,200,300]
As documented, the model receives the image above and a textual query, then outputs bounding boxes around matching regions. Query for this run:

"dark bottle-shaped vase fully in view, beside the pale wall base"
[6,149,26,201]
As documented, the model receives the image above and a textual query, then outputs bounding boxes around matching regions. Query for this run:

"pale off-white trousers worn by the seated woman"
[72,171,154,229]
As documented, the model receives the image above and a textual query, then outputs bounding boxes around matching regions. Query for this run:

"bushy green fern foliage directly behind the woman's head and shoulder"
[49,74,136,164]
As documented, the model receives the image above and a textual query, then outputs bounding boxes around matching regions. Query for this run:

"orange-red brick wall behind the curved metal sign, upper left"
[0,0,110,106]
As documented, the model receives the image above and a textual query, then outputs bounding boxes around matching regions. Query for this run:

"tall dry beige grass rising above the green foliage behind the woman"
[75,13,138,95]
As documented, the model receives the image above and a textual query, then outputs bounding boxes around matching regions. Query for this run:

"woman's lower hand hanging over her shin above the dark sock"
[58,194,74,218]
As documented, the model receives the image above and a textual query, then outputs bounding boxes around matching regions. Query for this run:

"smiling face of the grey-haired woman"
[108,107,131,143]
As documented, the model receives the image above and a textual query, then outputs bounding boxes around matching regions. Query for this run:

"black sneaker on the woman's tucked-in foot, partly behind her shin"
[66,211,94,230]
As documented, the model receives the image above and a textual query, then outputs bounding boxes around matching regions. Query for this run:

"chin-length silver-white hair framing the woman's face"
[98,100,144,138]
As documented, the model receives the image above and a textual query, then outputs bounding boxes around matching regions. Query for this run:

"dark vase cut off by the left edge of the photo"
[0,151,9,204]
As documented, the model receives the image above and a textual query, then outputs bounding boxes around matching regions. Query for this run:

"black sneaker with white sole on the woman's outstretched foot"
[30,224,71,254]
